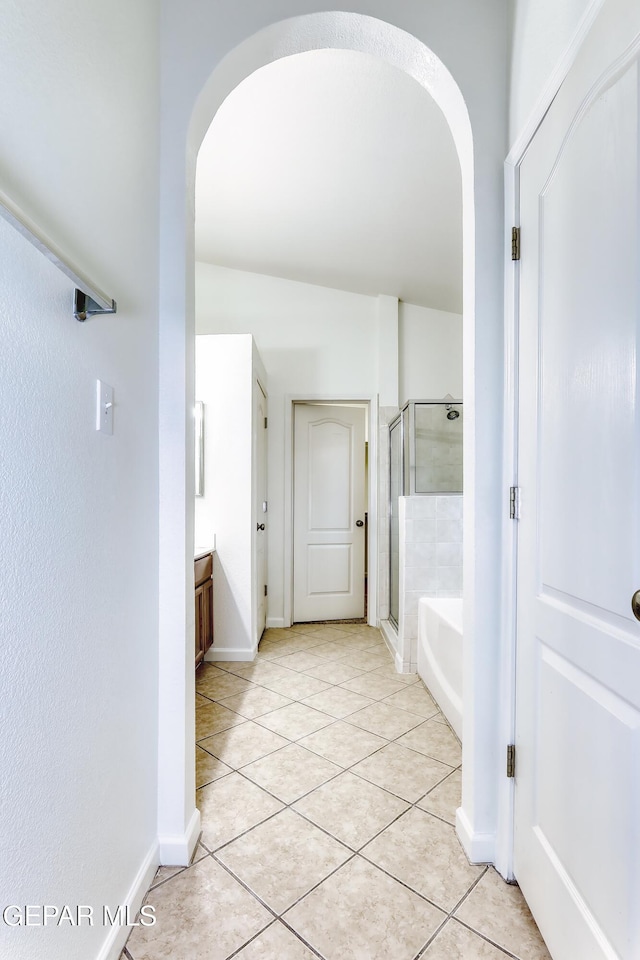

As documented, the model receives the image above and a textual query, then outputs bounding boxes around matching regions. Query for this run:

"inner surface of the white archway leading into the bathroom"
[158,12,492,863]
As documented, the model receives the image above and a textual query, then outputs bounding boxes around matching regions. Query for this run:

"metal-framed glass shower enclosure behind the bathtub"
[389,397,463,629]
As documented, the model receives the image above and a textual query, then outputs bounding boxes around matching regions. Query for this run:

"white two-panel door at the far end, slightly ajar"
[293,403,366,623]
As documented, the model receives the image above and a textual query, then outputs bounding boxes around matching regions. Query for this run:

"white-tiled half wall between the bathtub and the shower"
[398,494,462,666]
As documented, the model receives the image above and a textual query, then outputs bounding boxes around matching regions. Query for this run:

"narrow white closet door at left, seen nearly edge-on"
[253,380,268,642]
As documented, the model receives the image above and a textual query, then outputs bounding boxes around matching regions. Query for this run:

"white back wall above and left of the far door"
[196,263,378,626]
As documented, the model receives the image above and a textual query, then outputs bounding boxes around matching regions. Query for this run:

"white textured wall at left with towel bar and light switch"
[0,0,158,960]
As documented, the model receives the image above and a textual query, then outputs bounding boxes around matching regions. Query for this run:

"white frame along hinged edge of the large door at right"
[495,0,605,880]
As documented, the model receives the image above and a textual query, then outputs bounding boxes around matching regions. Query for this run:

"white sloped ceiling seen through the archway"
[196,50,462,313]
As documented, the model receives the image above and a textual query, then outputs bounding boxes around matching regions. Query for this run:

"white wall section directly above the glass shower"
[398,302,462,407]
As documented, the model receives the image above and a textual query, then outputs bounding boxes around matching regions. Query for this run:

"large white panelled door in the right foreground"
[514,0,640,960]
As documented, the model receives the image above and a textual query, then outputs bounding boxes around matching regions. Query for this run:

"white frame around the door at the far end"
[283,393,378,627]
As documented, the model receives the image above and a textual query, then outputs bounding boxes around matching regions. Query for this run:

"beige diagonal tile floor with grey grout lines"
[123,624,550,960]
